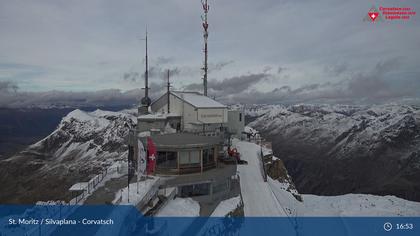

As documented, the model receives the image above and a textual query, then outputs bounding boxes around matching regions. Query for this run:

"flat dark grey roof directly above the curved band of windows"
[151,133,223,149]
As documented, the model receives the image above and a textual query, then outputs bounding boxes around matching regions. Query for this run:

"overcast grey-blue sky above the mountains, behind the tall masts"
[0,0,420,105]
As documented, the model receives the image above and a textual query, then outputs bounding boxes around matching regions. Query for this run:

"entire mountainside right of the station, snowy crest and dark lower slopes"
[247,105,420,201]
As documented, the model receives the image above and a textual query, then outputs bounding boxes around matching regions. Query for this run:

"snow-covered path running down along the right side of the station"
[236,142,286,216]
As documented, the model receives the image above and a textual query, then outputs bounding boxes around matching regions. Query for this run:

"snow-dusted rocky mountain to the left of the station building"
[0,110,136,203]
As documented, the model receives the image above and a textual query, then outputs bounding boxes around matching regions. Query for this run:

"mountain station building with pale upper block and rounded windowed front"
[132,91,245,175]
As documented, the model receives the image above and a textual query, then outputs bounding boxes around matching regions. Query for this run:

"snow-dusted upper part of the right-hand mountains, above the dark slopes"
[246,104,420,157]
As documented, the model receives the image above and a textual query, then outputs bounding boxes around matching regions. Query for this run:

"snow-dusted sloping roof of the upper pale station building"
[171,91,226,108]
